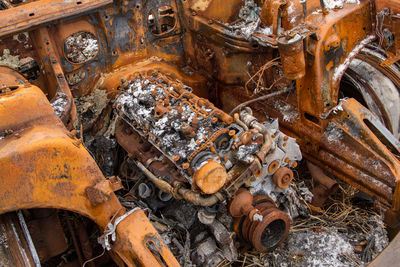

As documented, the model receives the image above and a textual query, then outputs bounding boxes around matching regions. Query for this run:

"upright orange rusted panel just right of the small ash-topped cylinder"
[296,1,372,118]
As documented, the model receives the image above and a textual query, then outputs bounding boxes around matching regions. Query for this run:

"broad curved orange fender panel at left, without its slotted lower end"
[0,85,121,227]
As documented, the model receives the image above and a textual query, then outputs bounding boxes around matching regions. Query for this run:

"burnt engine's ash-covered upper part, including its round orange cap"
[114,73,301,199]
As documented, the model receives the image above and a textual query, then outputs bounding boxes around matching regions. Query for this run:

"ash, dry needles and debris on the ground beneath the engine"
[122,160,389,266]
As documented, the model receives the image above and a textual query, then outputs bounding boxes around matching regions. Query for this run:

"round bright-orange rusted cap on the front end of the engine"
[193,159,228,194]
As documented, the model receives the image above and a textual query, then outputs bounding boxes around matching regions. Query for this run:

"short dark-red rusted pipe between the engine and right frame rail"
[307,161,338,207]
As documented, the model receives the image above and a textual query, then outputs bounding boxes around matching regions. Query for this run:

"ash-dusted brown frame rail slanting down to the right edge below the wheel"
[222,91,400,213]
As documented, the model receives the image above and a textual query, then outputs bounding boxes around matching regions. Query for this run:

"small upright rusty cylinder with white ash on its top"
[278,34,306,80]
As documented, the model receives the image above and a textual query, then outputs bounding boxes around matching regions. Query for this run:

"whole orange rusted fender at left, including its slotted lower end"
[0,84,178,266]
